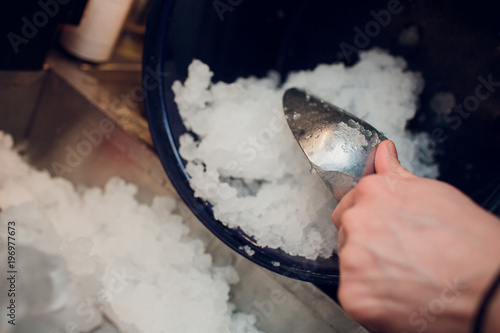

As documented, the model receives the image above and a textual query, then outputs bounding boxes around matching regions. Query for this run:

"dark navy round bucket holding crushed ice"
[143,0,500,284]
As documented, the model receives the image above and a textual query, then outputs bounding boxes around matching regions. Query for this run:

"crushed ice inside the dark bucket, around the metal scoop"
[172,50,437,259]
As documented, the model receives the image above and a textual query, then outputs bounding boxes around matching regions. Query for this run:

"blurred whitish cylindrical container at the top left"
[61,0,134,63]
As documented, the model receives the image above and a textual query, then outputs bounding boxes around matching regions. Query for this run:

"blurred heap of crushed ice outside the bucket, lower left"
[0,132,264,333]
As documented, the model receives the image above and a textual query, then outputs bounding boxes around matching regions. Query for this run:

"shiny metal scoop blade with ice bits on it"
[283,88,387,201]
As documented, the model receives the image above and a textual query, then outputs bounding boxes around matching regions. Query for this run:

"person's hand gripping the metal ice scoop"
[332,141,500,332]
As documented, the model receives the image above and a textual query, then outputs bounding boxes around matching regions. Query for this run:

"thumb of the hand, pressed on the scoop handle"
[375,140,416,178]
